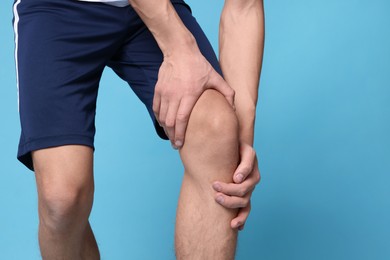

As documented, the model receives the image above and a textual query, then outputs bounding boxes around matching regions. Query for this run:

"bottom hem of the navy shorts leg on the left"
[17,135,95,171]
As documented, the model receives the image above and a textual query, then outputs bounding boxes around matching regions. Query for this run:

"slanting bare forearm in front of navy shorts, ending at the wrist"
[129,0,198,57]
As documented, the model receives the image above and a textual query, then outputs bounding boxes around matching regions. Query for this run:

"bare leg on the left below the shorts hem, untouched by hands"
[32,145,100,260]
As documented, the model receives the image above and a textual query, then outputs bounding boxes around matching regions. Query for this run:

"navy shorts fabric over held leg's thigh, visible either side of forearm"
[109,0,222,139]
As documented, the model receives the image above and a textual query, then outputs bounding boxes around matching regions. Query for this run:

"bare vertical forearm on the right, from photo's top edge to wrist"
[219,0,264,145]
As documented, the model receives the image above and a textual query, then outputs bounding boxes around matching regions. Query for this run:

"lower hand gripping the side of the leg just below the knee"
[213,143,260,230]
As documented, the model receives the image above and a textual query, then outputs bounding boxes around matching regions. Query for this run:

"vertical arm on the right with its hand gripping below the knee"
[213,0,264,229]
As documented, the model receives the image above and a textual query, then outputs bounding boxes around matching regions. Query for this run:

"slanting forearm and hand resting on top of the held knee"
[129,0,234,148]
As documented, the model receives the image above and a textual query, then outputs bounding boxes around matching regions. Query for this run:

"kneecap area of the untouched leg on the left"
[38,176,93,232]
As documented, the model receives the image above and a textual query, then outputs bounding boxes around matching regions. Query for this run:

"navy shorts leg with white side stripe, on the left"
[14,0,126,170]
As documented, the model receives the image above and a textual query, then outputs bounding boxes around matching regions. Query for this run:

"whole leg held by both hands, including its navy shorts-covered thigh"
[103,3,239,260]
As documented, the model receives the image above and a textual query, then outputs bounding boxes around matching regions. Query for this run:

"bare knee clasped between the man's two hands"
[180,90,239,179]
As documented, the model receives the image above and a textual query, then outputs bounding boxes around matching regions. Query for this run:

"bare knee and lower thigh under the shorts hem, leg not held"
[32,146,94,232]
